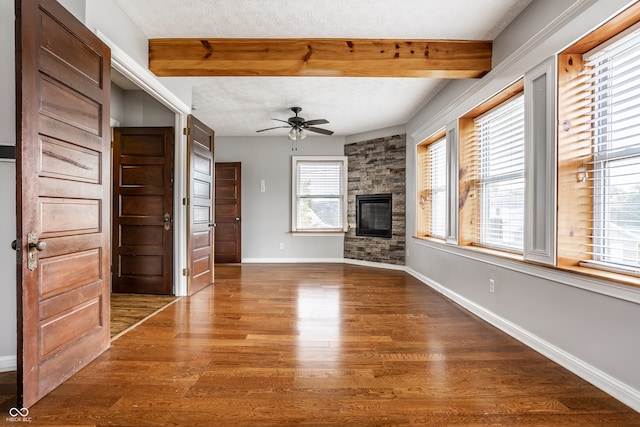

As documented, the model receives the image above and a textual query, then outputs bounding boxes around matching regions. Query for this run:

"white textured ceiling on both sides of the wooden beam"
[114,0,532,136]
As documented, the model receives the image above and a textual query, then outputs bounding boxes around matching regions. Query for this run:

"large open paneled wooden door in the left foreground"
[15,0,111,407]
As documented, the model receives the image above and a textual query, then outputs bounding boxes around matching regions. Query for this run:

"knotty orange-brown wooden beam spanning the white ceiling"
[149,38,492,79]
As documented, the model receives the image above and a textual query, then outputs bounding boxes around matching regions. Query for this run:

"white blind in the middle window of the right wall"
[475,94,524,253]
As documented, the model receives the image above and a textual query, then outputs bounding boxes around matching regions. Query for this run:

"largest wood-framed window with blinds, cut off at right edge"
[557,9,640,283]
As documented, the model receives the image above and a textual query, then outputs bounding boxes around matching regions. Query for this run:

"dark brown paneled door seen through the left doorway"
[112,127,174,295]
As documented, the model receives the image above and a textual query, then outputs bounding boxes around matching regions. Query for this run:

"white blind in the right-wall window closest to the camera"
[585,30,640,274]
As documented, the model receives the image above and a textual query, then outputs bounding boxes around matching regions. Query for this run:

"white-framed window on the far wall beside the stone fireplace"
[292,156,347,232]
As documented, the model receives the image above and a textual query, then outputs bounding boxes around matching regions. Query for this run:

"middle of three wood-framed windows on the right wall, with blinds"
[458,80,525,254]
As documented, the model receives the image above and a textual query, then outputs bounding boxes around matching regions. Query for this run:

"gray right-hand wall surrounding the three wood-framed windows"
[407,0,640,409]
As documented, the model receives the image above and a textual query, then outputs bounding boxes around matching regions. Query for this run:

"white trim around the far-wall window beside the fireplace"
[291,156,348,236]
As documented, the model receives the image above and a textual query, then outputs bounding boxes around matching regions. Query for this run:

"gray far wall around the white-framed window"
[215,135,344,262]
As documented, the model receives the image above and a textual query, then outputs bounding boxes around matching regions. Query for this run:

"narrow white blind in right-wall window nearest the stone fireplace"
[428,138,447,239]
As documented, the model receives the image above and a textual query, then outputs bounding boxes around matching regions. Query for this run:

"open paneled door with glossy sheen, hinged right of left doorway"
[187,115,214,295]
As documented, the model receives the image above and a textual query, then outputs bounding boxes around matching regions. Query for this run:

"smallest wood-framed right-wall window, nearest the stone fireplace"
[418,130,447,239]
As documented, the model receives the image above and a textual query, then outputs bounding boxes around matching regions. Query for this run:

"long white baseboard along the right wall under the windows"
[405,268,640,412]
